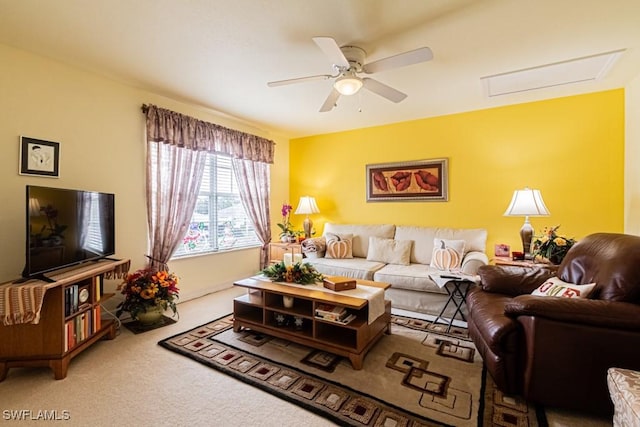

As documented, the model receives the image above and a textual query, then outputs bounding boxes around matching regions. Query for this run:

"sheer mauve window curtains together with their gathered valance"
[142,105,275,270]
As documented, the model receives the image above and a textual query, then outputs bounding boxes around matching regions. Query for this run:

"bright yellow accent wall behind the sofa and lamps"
[290,89,624,255]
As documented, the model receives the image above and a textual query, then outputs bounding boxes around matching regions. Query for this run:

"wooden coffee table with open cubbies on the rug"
[233,277,391,369]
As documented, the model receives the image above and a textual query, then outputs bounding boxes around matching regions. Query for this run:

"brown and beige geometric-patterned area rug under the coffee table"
[159,315,546,427]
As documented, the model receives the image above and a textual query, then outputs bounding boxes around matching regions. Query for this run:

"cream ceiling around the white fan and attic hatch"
[0,0,640,137]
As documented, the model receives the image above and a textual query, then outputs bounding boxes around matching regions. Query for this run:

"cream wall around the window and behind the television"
[0,45,289,300]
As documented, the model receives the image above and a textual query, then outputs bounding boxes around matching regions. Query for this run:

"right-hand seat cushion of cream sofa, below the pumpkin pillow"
[373,264,447,294]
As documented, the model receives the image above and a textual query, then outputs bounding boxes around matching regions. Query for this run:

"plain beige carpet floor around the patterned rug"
[0,289,611,427]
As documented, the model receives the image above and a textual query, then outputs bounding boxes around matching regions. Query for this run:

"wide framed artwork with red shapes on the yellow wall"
[366,158,449,202]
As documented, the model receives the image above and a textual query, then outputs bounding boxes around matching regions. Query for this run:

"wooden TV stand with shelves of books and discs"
[0,260,129,381]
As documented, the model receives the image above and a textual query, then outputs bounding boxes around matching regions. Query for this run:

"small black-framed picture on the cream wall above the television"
[19,136,60,178]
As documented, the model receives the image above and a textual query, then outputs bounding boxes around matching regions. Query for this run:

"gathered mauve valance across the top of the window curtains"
[142,105,275,163]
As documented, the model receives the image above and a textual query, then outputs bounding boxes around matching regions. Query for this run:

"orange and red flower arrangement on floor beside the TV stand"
[116,268,179,319]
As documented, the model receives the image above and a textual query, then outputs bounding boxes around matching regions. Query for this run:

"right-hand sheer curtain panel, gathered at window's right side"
[233,159,271,269]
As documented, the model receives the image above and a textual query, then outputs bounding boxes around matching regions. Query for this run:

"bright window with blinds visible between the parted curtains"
[173,154,261,257]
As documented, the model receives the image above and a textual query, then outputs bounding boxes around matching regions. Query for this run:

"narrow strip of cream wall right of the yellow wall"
[624,75,640,235]
